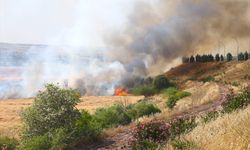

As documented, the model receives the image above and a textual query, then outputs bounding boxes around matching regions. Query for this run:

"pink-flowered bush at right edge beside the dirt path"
[222,89,250,113]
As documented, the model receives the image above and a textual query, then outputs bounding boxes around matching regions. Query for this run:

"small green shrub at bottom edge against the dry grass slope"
[171,139,196,150]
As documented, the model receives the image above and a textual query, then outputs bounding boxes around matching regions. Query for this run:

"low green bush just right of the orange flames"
[129,86,157,97]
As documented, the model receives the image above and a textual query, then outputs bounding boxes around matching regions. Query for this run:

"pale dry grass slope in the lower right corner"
[185,106,250,150]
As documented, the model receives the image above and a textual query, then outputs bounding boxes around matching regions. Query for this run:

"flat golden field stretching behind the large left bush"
[0,96,143,138]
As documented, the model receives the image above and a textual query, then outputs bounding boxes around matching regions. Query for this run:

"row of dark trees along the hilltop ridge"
[182,52,250,63]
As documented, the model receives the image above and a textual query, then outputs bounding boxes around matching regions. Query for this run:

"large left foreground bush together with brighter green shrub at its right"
[22,84,102,150]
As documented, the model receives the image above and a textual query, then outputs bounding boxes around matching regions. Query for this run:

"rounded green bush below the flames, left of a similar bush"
[95,104,131,128]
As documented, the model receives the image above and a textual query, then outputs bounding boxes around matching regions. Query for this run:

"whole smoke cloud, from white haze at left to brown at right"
[0,0,250,98]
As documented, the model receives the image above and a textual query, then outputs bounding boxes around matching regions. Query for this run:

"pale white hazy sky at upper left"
[0,0,135,48]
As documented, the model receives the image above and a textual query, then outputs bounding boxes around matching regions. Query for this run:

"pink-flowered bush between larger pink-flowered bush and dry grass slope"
[169,117,197,139]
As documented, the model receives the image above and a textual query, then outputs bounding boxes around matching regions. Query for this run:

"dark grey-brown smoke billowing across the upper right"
[106,0,250,76]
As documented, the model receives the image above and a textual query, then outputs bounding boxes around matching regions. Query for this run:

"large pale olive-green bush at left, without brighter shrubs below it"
[22,84,80,137]
